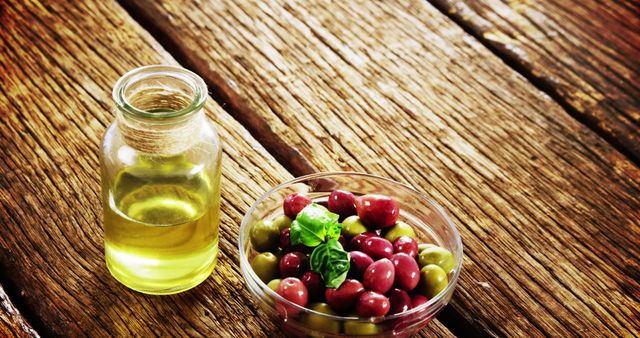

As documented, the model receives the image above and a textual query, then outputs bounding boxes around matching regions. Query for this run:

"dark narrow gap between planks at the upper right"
[424,0,640,167]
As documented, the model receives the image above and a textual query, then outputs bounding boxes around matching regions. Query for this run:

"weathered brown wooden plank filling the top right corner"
[431,0,640,163]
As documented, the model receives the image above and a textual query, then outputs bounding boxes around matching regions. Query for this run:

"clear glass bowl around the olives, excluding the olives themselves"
[238,172,462,337]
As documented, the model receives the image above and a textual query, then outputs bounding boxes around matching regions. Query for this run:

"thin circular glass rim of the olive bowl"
[238,171,464,322]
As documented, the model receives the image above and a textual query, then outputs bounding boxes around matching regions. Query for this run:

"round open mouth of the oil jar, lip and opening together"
[113,65,208,119]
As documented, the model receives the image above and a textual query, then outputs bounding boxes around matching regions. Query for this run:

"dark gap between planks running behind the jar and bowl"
[117,0,491,338]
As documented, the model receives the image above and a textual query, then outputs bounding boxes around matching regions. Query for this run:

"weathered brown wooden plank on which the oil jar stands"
[0,1,300,337]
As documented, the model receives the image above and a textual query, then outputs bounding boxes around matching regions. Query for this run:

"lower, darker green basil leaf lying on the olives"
[309,239,351,288]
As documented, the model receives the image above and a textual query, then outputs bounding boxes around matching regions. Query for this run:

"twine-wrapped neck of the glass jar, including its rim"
[113,66,207,156]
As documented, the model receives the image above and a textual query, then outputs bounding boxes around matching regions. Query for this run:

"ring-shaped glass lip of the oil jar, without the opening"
[112,65,208,119]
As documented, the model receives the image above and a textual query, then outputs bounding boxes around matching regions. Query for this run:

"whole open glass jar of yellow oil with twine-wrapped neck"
[100,66,221,294]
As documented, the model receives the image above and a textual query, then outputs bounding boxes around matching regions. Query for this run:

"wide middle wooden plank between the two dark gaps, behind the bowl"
[124,0,640,337]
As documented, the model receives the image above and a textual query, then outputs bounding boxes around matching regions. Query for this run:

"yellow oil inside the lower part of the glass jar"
[104,158,220,294]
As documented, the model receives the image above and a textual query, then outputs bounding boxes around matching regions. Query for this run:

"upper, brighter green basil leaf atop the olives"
[291,203,339,247]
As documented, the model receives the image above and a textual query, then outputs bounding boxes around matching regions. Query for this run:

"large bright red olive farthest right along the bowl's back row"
[356,195,400,228]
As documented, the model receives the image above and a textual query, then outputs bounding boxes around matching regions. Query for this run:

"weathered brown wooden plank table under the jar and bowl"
[0,0,640,337]
